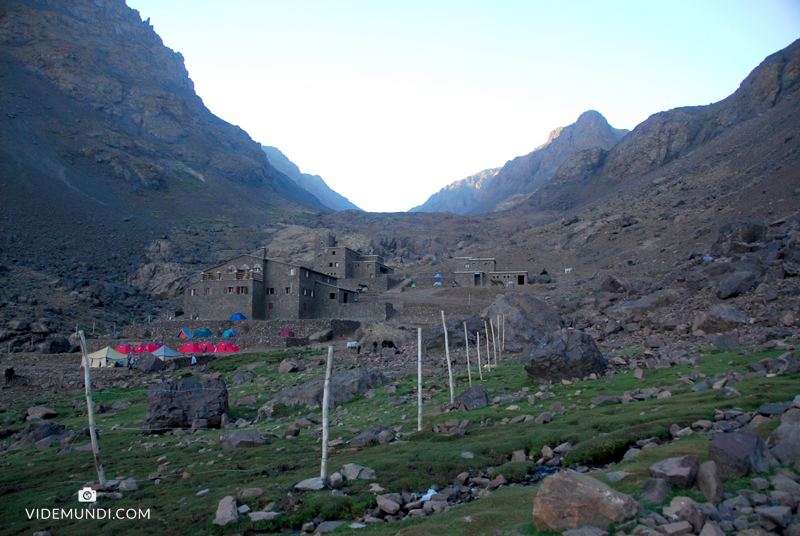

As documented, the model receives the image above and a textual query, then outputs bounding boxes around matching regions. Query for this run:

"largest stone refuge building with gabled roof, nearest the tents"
[183,248,391,320]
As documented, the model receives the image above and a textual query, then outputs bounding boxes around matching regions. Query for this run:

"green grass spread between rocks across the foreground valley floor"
[0,349,798,536]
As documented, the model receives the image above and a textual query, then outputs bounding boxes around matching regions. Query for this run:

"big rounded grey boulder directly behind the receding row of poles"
[481,292,561,352]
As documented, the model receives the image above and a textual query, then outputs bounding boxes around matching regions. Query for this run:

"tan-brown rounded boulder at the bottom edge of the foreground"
[533,470,636,532]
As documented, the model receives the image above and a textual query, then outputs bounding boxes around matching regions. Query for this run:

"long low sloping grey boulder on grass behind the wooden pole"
[268,369,389,414]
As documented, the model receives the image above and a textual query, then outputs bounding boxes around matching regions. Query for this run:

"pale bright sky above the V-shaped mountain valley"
[127,0,800,212]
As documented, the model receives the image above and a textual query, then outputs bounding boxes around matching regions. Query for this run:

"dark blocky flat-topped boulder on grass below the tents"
[142,378,229,434]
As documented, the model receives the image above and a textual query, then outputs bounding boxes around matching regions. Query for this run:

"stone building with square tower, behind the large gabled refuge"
[314,232,397,291]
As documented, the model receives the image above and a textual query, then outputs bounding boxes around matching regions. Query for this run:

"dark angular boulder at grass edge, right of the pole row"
[522,329,606,382]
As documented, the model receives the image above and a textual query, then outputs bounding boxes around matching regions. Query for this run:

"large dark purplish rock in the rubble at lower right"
[708,429,774,481]
